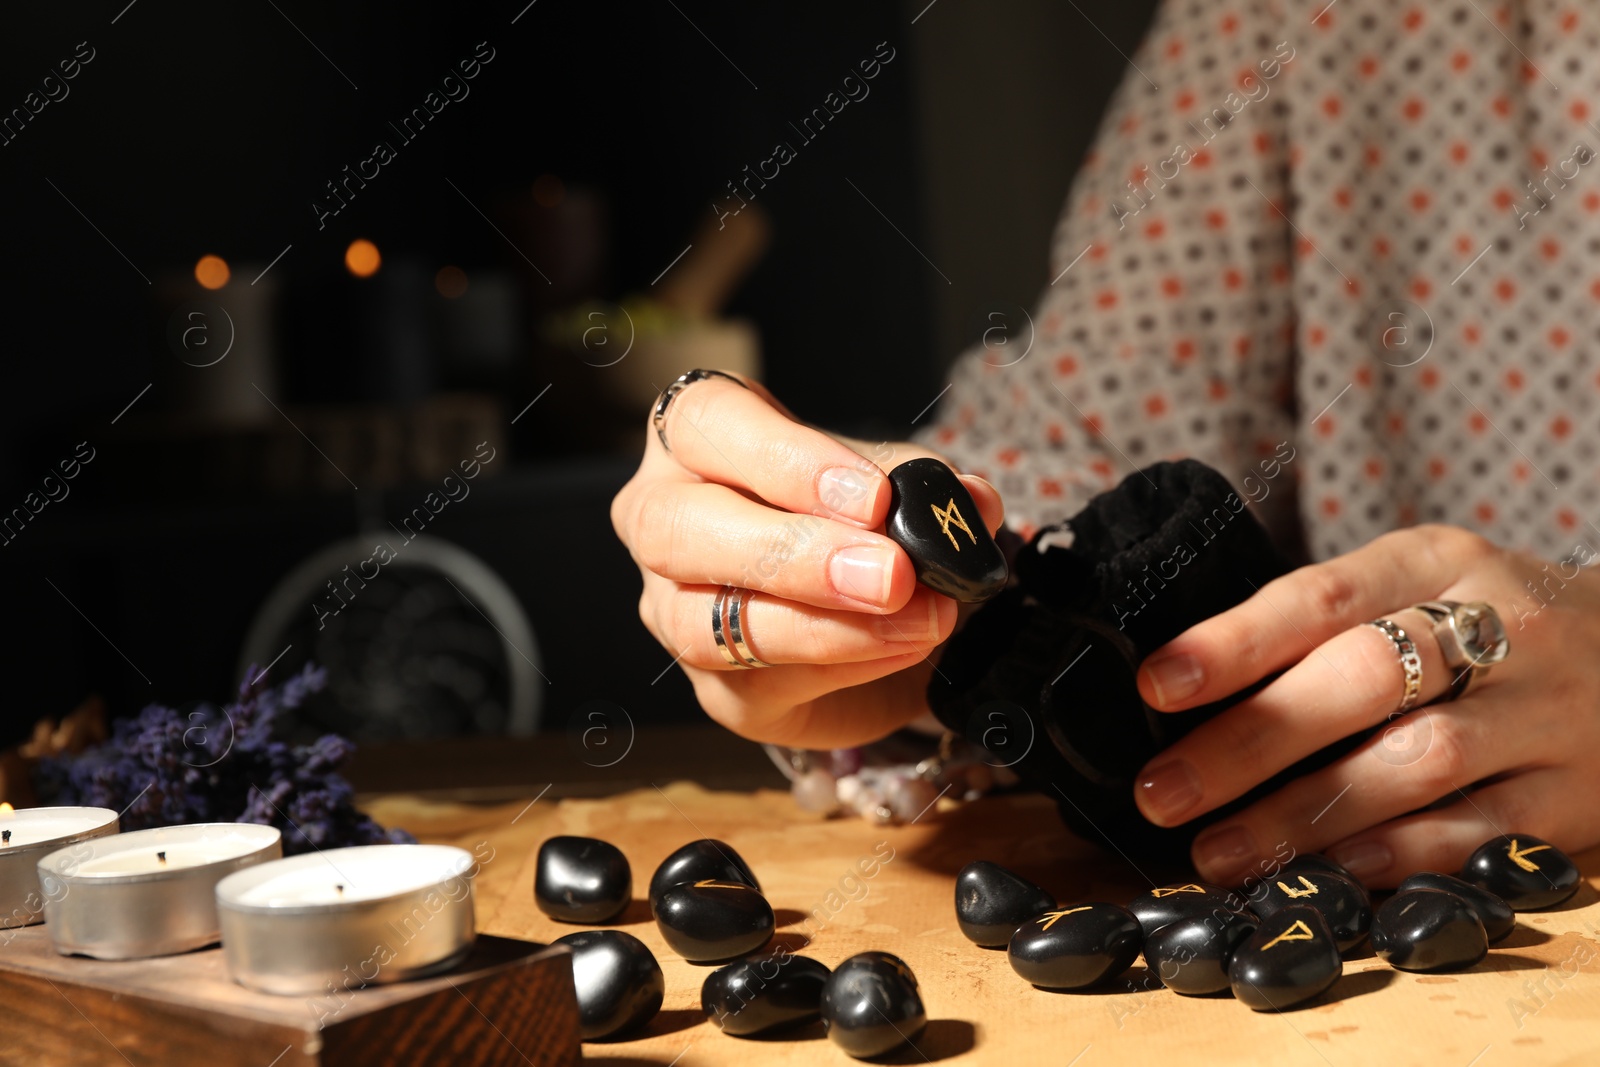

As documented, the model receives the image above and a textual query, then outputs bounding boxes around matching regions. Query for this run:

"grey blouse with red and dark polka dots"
[922,0,1600,558]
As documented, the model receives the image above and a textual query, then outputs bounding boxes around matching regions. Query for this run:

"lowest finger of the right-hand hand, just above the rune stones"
[1328,768,1595,889]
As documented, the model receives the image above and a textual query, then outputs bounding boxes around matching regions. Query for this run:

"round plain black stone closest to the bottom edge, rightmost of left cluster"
[822,952,928,1059]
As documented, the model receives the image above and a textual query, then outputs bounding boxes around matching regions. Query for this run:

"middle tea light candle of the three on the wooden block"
[38,822,283,960]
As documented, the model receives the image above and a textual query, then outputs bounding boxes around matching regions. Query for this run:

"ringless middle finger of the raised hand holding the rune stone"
[629,482,917,614]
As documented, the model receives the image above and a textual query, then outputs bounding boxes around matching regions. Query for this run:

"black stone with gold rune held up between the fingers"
[885,459,1008,603]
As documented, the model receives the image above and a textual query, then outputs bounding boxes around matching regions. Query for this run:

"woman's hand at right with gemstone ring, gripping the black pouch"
[1136,526,1600,888]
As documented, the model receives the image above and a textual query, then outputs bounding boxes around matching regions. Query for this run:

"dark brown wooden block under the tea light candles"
[0,926,579,1067]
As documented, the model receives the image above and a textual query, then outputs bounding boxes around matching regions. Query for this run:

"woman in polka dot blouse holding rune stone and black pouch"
[613,0,1600,886]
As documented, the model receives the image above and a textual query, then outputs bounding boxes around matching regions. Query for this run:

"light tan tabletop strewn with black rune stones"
[370,782,1600,1067]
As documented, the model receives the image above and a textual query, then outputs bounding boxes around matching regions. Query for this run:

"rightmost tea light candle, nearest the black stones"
[216,845,477,1013]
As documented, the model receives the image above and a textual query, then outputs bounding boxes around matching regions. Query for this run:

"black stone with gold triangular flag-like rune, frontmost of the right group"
[1227,904,1344,1011]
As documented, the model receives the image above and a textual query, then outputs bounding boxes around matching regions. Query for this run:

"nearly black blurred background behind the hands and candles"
[0,0,1150,742]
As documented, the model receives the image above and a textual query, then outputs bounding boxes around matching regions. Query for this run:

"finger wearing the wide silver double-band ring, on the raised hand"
[646,577,958,670]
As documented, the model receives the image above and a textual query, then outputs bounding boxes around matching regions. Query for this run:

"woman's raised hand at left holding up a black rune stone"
[611,378,1002,749]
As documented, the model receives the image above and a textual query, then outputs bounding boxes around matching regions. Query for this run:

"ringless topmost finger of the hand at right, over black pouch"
[1139,526,1496,710]
